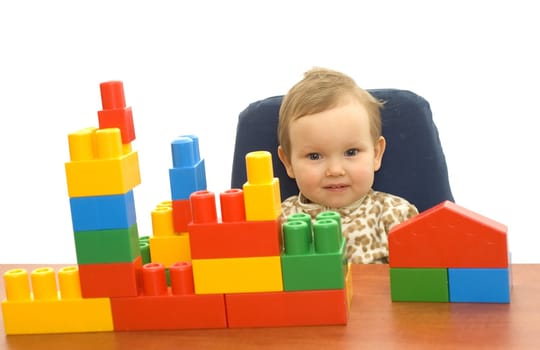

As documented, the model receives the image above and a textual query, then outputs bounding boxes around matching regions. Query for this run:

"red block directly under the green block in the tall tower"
[79,256,142,298]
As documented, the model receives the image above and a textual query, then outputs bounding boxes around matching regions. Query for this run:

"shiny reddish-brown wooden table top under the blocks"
[0,264,540,350]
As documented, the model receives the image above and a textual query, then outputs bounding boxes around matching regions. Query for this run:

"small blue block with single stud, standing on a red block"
[169,136,206,200]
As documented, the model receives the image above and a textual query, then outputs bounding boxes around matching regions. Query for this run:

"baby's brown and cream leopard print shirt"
[281,190,418,264]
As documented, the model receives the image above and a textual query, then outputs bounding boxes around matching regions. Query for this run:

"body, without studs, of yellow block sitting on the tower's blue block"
[65,151,141,198]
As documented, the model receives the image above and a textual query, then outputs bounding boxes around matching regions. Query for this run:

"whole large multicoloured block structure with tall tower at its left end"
[2,81,352,334]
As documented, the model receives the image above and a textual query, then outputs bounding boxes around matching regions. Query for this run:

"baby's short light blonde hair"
[278,67,383,157]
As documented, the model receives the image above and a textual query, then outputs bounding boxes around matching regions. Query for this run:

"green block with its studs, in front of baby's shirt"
[281,213,348,291]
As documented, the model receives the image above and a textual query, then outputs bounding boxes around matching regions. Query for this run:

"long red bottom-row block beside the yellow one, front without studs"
[111,289,227,331]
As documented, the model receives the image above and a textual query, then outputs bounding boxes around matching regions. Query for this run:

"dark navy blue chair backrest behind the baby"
[231,89,454,211]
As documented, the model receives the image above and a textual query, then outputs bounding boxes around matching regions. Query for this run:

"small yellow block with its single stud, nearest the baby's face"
[242,151,281,221]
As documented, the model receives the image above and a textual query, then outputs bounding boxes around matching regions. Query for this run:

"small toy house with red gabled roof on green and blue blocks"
[388,201,511,303]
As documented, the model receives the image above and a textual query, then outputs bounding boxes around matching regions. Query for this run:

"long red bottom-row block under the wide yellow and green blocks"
[225,289,348,328]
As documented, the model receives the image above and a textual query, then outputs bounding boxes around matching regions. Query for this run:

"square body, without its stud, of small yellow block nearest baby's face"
[243,177,281,221]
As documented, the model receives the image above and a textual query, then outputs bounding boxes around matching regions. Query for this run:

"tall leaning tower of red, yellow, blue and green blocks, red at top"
[65,81,142,298]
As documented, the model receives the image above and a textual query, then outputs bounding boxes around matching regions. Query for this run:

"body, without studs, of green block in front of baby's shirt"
[281,240,348,291]
